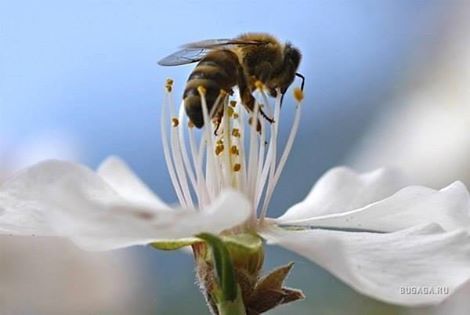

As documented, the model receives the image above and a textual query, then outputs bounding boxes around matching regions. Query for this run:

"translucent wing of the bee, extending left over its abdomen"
[158,39,264,66]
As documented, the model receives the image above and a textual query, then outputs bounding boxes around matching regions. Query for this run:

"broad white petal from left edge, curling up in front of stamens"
[0,161,251,250]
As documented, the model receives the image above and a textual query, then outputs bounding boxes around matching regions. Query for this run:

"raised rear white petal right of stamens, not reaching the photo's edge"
[279,167,407,221]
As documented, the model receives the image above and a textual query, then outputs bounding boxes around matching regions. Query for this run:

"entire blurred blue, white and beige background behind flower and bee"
[0,0,470,315]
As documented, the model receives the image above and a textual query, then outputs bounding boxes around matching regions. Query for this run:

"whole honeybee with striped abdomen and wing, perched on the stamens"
[158,33,305,130]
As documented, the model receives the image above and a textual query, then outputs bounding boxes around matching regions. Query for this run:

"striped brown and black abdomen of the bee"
[183,50,241,128]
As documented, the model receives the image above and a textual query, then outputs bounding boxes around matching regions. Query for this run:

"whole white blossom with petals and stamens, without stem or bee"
[0,80,470,305]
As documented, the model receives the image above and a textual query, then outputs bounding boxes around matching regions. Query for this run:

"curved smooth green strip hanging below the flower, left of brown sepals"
[197,233,238,301]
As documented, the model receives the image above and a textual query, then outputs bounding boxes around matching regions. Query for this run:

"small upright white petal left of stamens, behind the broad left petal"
[97,156,170,209]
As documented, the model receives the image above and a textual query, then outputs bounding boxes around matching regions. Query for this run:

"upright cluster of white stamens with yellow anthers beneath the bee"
[161,80,303,225]
